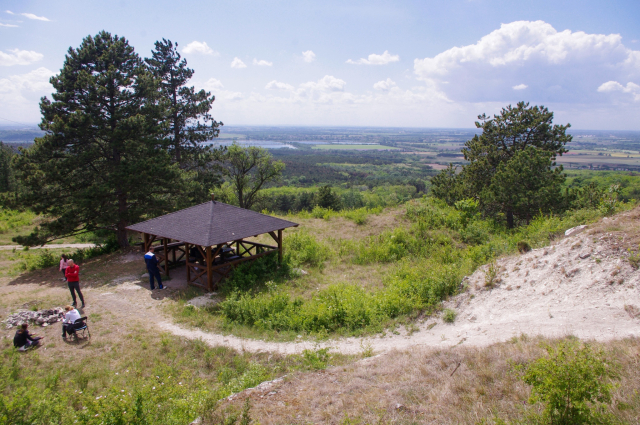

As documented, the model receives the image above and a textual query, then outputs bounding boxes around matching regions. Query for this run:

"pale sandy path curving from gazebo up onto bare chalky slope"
[5,210,640,354]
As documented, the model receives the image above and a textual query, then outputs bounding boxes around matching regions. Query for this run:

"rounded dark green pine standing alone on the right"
[431,102,571,227]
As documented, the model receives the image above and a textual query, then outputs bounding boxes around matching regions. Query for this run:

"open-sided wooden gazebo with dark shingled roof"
[127,199,298,291]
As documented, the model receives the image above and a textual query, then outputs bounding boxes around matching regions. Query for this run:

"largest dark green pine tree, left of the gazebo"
[14,31,182,247]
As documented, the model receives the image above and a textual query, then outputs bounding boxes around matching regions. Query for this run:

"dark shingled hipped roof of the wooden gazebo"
[127,201,298,246]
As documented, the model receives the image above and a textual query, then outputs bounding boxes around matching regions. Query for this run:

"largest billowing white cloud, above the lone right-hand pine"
[414,21,640,104]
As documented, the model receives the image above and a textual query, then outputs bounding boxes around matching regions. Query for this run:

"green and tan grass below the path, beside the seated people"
[0,304,350,424]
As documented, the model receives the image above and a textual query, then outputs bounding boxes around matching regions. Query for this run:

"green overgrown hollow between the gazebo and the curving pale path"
[169,198,632,339]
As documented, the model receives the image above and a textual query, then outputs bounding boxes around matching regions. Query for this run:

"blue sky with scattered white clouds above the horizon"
[0,0,640,130]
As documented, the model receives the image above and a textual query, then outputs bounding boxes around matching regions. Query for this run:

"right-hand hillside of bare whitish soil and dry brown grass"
[216,208,640,424]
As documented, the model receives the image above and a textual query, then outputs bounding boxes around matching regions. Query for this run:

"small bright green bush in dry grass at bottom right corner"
[520,340,618,425]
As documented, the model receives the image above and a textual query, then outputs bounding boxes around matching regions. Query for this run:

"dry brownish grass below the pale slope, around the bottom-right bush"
[218,335,640,425]
